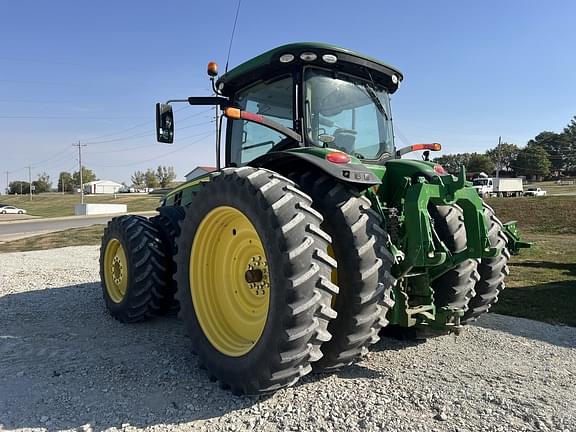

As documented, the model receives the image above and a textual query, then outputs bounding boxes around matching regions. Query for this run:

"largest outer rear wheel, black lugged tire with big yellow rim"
[176,167,338,395]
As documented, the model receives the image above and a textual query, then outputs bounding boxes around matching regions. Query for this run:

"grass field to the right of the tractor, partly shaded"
[488,196,576,326]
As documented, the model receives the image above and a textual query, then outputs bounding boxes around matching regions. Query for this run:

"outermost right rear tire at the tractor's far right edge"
[462,203,510,324]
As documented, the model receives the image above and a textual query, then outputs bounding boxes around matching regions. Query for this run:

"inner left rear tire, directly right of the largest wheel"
[292,172,395,371]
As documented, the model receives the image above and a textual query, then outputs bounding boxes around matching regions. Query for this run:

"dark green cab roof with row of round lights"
[216,42,404,96]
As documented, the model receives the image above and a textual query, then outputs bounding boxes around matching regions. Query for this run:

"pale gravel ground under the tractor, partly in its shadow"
[0,246,576,431]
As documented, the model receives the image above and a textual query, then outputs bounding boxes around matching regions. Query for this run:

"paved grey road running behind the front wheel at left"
[0,211,156,242]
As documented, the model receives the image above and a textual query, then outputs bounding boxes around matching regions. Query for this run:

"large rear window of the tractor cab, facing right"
[304,68,394,160]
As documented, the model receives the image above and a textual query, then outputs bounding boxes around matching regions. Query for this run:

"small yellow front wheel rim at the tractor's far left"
[104,238,128,303]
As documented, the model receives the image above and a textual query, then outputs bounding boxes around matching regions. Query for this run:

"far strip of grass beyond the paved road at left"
[0,193,160,217]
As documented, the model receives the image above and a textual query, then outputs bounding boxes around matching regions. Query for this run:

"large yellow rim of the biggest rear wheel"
[189,206,270,357]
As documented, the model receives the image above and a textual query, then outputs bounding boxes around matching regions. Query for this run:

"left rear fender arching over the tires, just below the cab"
[250,151,382,190]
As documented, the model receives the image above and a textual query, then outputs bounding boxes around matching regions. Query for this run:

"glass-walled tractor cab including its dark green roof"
[216,43,402,166]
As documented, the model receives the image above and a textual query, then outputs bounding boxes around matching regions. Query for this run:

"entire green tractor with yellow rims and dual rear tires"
[100,43,525,394]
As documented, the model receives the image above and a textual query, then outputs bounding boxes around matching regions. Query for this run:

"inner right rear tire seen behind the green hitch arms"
[428,205,480,311]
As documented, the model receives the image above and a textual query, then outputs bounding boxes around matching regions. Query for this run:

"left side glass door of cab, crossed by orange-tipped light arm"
[226,75,297,166]
